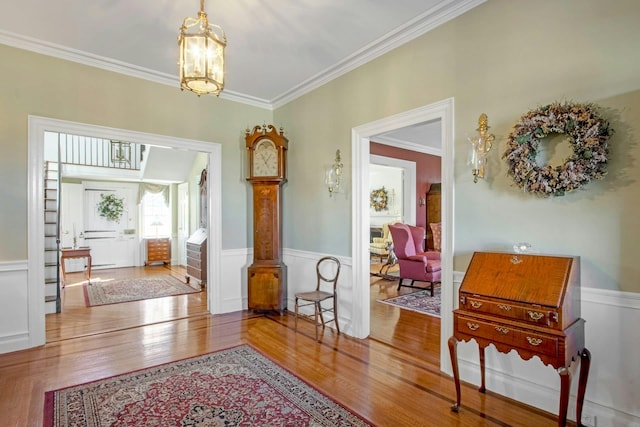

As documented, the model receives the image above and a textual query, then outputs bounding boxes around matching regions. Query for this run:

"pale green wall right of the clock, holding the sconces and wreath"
[275,0,640,292]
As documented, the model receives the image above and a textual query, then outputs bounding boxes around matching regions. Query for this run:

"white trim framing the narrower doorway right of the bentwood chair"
[351,98,455,373]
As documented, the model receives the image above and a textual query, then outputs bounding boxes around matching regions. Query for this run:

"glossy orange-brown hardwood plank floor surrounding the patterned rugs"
[0,269,557,427]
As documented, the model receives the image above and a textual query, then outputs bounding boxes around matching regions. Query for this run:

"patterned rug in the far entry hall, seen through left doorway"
[84,275,200,307]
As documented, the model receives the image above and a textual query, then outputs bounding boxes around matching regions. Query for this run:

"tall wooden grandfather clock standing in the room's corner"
[245,125,289,313]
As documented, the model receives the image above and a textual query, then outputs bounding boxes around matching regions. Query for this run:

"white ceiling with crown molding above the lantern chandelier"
[0,0,485,108]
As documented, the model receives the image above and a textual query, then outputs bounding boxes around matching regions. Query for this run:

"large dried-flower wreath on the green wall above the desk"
[502,102,613,196]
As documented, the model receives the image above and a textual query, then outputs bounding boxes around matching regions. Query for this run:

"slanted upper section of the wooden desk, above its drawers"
[460,252,580,307]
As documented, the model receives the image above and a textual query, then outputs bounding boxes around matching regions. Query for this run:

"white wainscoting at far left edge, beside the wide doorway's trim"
[0,261,31,353]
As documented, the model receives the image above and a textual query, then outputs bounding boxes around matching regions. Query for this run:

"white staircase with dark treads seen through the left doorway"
[44,161,62,314]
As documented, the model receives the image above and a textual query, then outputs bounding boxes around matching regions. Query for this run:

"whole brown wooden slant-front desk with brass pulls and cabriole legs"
[449,252,591,426]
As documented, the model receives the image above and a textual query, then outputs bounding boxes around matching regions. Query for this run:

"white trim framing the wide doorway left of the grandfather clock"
[27,116,222,347]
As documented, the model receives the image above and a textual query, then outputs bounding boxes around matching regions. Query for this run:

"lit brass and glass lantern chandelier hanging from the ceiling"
[178,0,227,96]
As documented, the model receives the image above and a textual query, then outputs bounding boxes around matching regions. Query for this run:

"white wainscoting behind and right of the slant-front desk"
[452,272,640,427]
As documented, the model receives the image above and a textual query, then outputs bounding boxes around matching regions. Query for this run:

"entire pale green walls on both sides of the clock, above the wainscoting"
[0,0,640,292]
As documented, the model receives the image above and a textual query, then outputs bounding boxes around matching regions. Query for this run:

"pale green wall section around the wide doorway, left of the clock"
[0,45,272,261]
